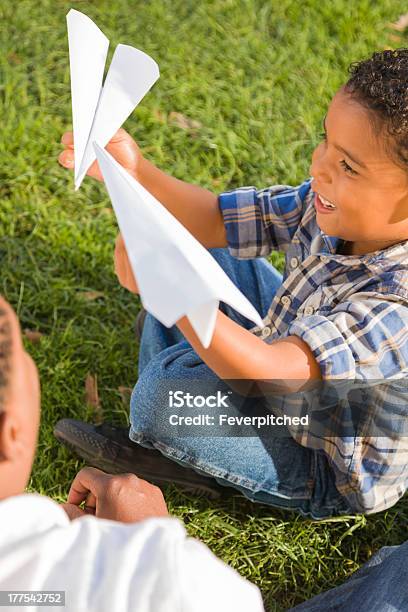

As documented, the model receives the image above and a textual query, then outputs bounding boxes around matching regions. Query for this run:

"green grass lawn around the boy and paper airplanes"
[0,0,408,610]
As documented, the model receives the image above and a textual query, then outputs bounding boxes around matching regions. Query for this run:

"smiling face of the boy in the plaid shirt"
[310,89,408,255]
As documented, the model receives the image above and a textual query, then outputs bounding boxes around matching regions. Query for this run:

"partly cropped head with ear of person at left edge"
[0,298,40,499]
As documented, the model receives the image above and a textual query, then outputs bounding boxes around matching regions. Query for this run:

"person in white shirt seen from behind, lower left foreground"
[0,298,263,612]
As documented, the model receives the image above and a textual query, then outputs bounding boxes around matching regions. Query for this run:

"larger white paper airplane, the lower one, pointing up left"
[94,143,264,348]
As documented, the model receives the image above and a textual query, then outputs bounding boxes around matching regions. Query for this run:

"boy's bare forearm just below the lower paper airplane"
[177,311,322,392]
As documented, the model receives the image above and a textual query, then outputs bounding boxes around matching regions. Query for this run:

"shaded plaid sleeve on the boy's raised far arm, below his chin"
[218,179,313,259]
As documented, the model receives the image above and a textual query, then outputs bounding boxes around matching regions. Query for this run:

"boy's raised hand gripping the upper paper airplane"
[58,128,143,181]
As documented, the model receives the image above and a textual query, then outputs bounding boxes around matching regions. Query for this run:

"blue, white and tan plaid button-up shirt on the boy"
[219,180,408,513]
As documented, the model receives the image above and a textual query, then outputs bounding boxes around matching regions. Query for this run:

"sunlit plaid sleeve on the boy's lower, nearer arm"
[285,293,408,380]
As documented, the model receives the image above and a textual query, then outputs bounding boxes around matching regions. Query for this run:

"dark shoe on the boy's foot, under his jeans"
[54,419,230,499]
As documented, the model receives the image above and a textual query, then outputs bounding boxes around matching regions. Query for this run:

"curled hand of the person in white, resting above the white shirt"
[68,467,168,523]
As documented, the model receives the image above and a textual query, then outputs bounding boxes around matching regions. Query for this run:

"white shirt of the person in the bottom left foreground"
[0,494,263,612]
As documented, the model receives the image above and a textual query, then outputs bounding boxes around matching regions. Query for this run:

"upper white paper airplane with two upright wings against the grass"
[67,9,160,189]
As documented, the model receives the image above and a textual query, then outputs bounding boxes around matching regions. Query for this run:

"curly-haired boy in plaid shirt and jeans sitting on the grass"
[56,49,408,518]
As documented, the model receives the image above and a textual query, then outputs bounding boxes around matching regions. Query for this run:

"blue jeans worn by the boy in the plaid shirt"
[129,249,352,519]
